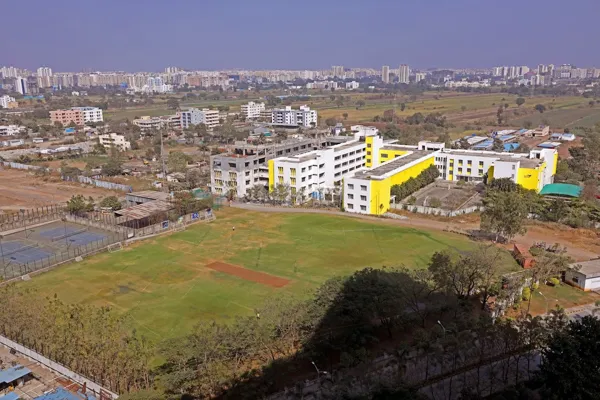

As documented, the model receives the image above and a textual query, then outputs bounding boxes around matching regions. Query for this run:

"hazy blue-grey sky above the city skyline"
[0,0,600,71]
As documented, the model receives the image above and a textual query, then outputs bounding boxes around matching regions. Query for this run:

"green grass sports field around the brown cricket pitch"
[23,208,516,340]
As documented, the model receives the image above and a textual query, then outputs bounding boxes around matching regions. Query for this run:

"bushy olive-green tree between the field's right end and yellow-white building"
[481,190,528,241]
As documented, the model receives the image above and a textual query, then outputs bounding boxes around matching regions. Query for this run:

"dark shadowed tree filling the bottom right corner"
[539,316,600,400]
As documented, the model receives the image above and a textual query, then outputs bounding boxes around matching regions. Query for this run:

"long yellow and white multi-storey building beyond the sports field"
[268,125,558,215]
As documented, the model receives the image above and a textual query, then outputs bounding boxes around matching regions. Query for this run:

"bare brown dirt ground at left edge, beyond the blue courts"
[0,169,123,211]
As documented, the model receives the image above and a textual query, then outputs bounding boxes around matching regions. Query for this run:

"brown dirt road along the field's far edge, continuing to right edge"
[232,203,600,261]
